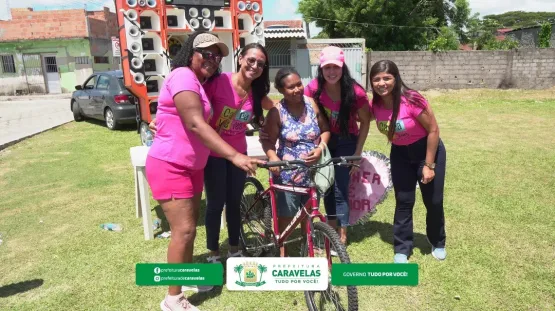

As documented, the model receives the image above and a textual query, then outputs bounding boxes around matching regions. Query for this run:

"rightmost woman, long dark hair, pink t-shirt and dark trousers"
[370,60,447,263]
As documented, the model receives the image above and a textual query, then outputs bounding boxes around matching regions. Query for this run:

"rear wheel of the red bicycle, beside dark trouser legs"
[240,177,273,257]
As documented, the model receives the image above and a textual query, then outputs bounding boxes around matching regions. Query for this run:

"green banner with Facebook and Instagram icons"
[135,263,224,286]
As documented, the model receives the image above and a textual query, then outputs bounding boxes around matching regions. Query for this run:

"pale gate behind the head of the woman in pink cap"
[296,39,366,87]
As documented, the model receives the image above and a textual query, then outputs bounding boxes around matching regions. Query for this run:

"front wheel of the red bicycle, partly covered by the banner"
[303,222,358,311]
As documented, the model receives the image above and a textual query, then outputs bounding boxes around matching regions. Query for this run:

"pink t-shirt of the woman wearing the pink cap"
[304,79,369,135]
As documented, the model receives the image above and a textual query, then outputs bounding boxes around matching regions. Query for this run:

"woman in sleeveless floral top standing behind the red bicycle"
[262,68,330,256]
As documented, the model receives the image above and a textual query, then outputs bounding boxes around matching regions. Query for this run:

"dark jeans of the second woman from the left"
[204,156,247,251]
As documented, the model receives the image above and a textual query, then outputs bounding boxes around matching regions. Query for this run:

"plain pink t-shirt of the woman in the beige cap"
[148,67,212,170]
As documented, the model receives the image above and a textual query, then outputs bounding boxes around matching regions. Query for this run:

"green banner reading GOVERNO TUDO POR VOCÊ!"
[331,263,418,286]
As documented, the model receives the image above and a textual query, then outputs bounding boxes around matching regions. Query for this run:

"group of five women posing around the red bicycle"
[146,32,446,311]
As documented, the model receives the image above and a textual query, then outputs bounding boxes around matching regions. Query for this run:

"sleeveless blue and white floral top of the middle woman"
[274,97,320,187]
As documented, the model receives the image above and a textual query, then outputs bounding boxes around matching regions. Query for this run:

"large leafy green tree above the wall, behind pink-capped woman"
[298,0,470,51]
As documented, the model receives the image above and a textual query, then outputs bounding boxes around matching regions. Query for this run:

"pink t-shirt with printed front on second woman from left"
[204,72,253,157]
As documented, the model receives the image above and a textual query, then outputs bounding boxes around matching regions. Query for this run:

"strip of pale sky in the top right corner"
[468,0,555,16]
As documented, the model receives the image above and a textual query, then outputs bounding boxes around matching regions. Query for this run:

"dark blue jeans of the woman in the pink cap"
[324,134,358,227]
